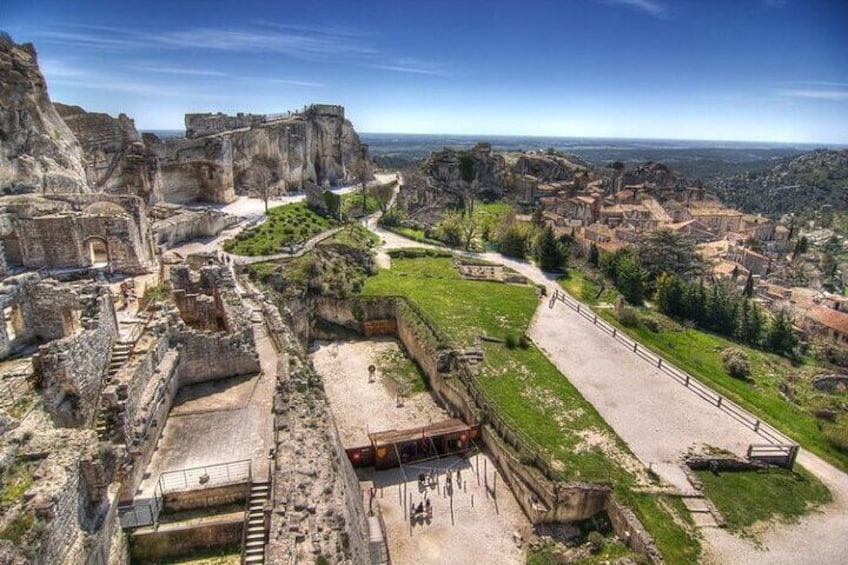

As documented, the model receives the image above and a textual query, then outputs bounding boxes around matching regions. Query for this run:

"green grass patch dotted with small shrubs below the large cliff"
[224,202,339,256]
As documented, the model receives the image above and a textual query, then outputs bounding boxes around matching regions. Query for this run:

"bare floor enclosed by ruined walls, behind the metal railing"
[139,310,277,495]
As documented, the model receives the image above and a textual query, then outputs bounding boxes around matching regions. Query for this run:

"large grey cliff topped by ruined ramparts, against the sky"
[153,105,368,202]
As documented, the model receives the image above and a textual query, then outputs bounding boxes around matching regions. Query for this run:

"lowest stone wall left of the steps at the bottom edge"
[131,514,244,564]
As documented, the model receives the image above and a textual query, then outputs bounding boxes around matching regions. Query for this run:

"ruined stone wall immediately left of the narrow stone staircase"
[33,287,118,427]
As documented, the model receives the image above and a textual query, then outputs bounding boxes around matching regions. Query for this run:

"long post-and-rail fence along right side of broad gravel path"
[548,289,797,447]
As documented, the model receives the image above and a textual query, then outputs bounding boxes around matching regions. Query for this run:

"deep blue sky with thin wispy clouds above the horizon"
[0,0,848,143]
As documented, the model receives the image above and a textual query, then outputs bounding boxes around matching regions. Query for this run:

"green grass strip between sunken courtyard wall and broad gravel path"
[363,258,700,563]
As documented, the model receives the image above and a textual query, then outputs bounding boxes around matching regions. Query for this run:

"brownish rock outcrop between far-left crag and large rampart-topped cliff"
[54,103,162,203]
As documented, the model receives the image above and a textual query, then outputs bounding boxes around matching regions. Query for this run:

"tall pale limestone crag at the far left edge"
[0,32,89,194]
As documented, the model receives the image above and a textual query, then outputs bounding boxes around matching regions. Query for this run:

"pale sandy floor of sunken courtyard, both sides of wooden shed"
[312,340,530,564]
